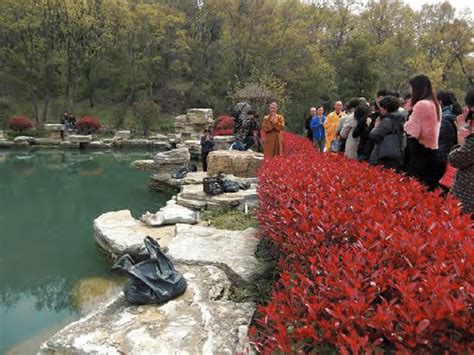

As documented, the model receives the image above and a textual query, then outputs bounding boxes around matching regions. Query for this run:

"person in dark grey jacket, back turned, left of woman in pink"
[369,95,405,170]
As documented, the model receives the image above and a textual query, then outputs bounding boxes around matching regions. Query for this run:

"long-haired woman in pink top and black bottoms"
[404,75,444,191]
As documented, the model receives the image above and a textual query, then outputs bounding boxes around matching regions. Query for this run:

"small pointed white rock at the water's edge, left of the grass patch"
[141,200,199,227]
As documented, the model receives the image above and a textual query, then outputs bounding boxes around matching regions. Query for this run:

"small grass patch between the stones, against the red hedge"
[200,210,258,230]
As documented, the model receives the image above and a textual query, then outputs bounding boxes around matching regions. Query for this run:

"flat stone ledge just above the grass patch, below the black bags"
[176,184,257,210]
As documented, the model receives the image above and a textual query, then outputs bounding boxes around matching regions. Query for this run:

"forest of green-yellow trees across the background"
[0,0,474,130]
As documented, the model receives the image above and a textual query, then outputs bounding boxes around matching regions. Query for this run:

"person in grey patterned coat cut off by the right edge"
[448,89,474,218]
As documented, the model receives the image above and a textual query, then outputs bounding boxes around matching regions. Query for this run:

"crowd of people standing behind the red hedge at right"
[305,75,474,213]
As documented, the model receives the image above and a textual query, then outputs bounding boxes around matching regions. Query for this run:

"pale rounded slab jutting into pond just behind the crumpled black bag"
[94,210,174,259]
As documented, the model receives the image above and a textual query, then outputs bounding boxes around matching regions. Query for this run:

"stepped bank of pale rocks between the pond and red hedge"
[39,143,263,354]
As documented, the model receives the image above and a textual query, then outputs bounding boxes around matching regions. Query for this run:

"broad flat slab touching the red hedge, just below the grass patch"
[168,224,260,283]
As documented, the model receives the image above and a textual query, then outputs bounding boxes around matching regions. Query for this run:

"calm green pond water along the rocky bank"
[0,151,169,354]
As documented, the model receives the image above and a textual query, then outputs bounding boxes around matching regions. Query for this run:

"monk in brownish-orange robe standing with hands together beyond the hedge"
[262,102,285,157]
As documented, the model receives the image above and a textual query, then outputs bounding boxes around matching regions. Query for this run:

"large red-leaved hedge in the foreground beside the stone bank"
[250,134,474,354]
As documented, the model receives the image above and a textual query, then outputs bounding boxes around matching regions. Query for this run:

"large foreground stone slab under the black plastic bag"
[39,264,256,355]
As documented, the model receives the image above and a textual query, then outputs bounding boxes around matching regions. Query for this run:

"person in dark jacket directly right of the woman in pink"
[436,91,461,165]
